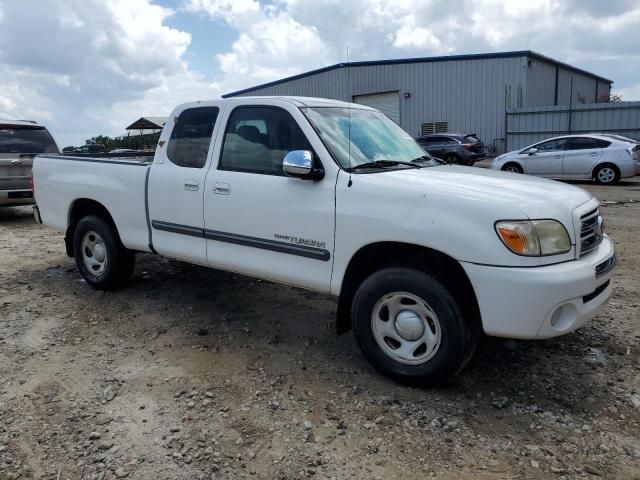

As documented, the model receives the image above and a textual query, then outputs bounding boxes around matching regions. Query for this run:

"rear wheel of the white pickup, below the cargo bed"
[73,215,135,291]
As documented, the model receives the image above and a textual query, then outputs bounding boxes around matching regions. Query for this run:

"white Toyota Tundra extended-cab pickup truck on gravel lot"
[33,97,615,385]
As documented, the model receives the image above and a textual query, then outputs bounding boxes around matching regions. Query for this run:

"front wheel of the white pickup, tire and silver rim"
[352,267,478,387]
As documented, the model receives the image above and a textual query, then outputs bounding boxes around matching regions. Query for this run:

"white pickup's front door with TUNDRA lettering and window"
[205,101,337,291]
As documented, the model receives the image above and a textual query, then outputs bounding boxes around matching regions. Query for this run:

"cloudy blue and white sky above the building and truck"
[0,0,640,147]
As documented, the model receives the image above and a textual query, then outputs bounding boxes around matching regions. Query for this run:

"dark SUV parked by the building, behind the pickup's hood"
[416,133,486,165]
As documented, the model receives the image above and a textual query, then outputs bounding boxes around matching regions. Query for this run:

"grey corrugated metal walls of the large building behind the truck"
[234,56,608,153]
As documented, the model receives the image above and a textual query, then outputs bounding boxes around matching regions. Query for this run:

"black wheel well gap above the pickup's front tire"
[336,242,482,334]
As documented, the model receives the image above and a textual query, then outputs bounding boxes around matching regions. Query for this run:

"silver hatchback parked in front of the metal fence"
[491,134,640,185]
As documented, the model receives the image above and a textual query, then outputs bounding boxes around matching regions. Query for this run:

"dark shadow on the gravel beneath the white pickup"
[12,251,631,424]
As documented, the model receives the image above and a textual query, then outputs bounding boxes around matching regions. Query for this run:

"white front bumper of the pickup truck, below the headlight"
[461,236,615,339]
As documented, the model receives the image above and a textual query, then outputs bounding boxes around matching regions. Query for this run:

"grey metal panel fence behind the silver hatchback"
[507,99,640,150]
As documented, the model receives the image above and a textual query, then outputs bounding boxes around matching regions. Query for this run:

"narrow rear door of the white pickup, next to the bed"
[148,106,219,265]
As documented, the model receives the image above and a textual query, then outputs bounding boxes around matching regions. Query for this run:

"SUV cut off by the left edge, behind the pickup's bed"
[0,120,59,207]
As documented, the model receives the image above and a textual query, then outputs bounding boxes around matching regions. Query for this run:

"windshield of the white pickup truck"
[303,107,437,170]
